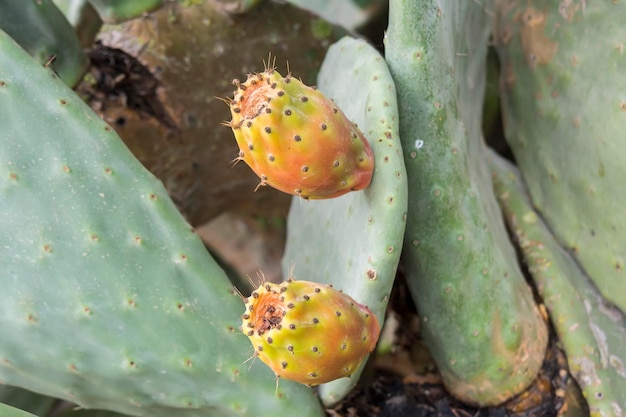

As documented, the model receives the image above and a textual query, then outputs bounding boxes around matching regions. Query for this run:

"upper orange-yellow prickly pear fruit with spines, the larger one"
[227,67,374,199]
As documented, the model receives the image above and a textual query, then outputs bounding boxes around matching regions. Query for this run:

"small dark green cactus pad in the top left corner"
[0,0,88,86]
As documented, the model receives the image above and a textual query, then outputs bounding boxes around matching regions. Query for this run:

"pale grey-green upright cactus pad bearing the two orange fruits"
[283,37,407,404]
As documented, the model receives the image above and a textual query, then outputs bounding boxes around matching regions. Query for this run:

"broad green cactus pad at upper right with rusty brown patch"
[495,0,626,311]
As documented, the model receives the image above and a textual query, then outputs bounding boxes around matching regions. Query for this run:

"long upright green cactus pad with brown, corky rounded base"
[385,0,547,405]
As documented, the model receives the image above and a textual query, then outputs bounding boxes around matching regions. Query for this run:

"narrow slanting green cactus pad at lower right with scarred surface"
[492,155,626,417]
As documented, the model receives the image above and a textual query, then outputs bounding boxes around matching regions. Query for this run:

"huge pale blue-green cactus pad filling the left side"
[0,32,323,417]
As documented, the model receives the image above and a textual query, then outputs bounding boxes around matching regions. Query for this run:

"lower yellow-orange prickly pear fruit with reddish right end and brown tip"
[242,279,380,386]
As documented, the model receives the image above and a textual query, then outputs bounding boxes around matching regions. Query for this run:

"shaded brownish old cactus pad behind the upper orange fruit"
[88,0,341,226]
